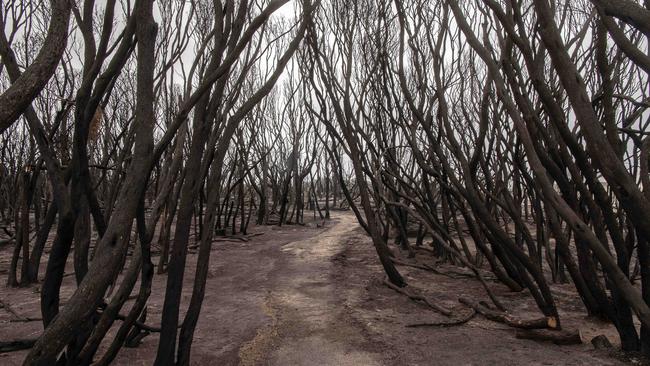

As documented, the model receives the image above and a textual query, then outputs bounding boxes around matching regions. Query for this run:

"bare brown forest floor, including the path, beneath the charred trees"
[0,212,640,366]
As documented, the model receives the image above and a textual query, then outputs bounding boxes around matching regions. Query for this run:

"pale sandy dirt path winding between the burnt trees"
[240,215,380,366]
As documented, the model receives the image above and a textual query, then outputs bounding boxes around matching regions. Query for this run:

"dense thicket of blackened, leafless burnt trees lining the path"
[0,0,650,365]
